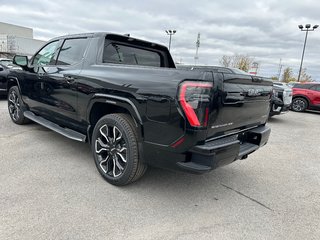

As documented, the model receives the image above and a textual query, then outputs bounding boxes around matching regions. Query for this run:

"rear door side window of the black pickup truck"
[56,38,88,65]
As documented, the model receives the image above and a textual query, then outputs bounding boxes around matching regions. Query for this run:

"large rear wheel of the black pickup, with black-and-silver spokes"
[91,114,147,186]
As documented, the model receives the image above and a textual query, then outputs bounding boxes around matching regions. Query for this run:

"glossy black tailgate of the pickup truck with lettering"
[207,73,272,138]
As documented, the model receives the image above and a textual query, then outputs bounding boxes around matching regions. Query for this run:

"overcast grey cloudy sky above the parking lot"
[0,0,320,81]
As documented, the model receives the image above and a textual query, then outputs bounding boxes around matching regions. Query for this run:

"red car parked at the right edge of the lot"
[291,82,320,112]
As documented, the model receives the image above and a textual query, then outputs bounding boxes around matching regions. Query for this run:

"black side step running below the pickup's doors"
[23,111,87,142]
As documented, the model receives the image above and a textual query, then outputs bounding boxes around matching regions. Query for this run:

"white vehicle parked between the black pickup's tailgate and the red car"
[269,82,292,117]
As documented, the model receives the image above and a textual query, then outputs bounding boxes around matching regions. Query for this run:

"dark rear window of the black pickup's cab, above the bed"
[103,43,161,67]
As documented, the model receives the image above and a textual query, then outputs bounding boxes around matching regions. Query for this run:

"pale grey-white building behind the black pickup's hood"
[0,22,45,58]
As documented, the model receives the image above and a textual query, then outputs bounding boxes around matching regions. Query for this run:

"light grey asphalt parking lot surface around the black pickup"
[0,98,320,240]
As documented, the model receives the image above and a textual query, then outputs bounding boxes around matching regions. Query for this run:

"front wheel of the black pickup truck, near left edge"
[8,86,30,125]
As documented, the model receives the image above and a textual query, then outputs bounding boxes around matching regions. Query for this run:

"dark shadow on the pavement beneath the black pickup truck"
[11,124,261,208]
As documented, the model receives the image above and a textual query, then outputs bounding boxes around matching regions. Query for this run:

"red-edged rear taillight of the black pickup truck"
[179,81,213,127]
